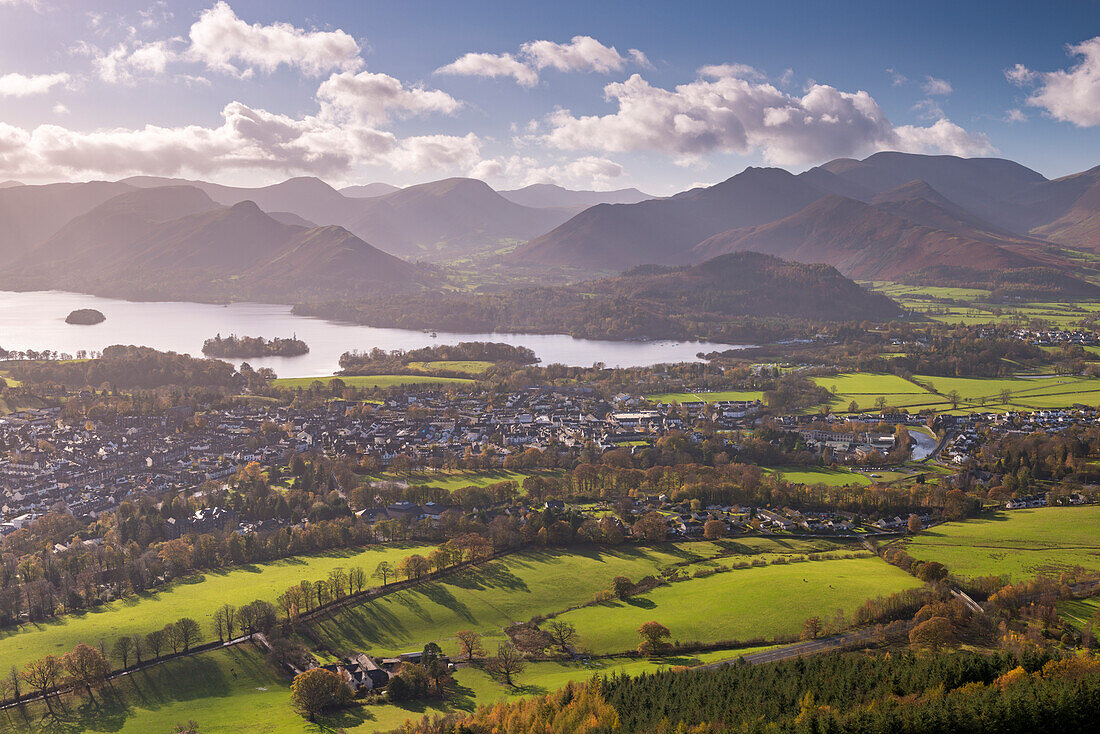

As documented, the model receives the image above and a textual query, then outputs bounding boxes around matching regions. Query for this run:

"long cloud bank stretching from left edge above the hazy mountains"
[0,73,482,177]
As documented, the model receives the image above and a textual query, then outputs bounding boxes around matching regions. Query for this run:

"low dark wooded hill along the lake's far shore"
[295,252,902,341]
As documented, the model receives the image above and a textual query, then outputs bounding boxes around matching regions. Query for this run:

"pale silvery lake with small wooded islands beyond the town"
[0,291,743,377]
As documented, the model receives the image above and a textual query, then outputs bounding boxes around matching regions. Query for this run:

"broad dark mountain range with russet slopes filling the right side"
[512,153,1100,290]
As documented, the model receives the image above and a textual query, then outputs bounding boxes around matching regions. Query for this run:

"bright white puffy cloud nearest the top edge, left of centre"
[186,0,363,76]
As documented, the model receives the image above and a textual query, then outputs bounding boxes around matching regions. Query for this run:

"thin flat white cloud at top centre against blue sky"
[436,35,650,87]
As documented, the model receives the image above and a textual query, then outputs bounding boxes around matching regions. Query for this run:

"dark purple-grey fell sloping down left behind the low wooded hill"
[512,168,825,270]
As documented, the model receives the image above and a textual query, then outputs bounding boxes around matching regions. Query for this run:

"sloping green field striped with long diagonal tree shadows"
[314,543,719,655]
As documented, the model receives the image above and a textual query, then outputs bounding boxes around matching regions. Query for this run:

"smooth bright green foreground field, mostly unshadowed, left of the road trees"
[558,558,921,654]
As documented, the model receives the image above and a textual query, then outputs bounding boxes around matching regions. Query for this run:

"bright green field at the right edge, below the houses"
[908,506,1100,581]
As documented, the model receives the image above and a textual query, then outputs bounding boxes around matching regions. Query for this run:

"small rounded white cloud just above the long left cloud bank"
[317,72,462,123]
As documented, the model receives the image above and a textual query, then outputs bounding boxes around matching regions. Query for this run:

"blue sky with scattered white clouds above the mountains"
[0,0,1100,195]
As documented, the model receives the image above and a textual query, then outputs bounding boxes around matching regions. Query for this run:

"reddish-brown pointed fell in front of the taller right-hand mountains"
[694,196,1038,280]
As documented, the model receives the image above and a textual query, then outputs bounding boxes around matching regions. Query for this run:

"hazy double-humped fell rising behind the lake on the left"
[2,191,416,302]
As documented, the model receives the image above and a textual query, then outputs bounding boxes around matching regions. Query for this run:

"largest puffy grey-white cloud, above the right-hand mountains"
[546,73,994,165]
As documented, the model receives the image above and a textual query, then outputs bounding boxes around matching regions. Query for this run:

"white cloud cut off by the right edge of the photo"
[1004,36,1100,128]
